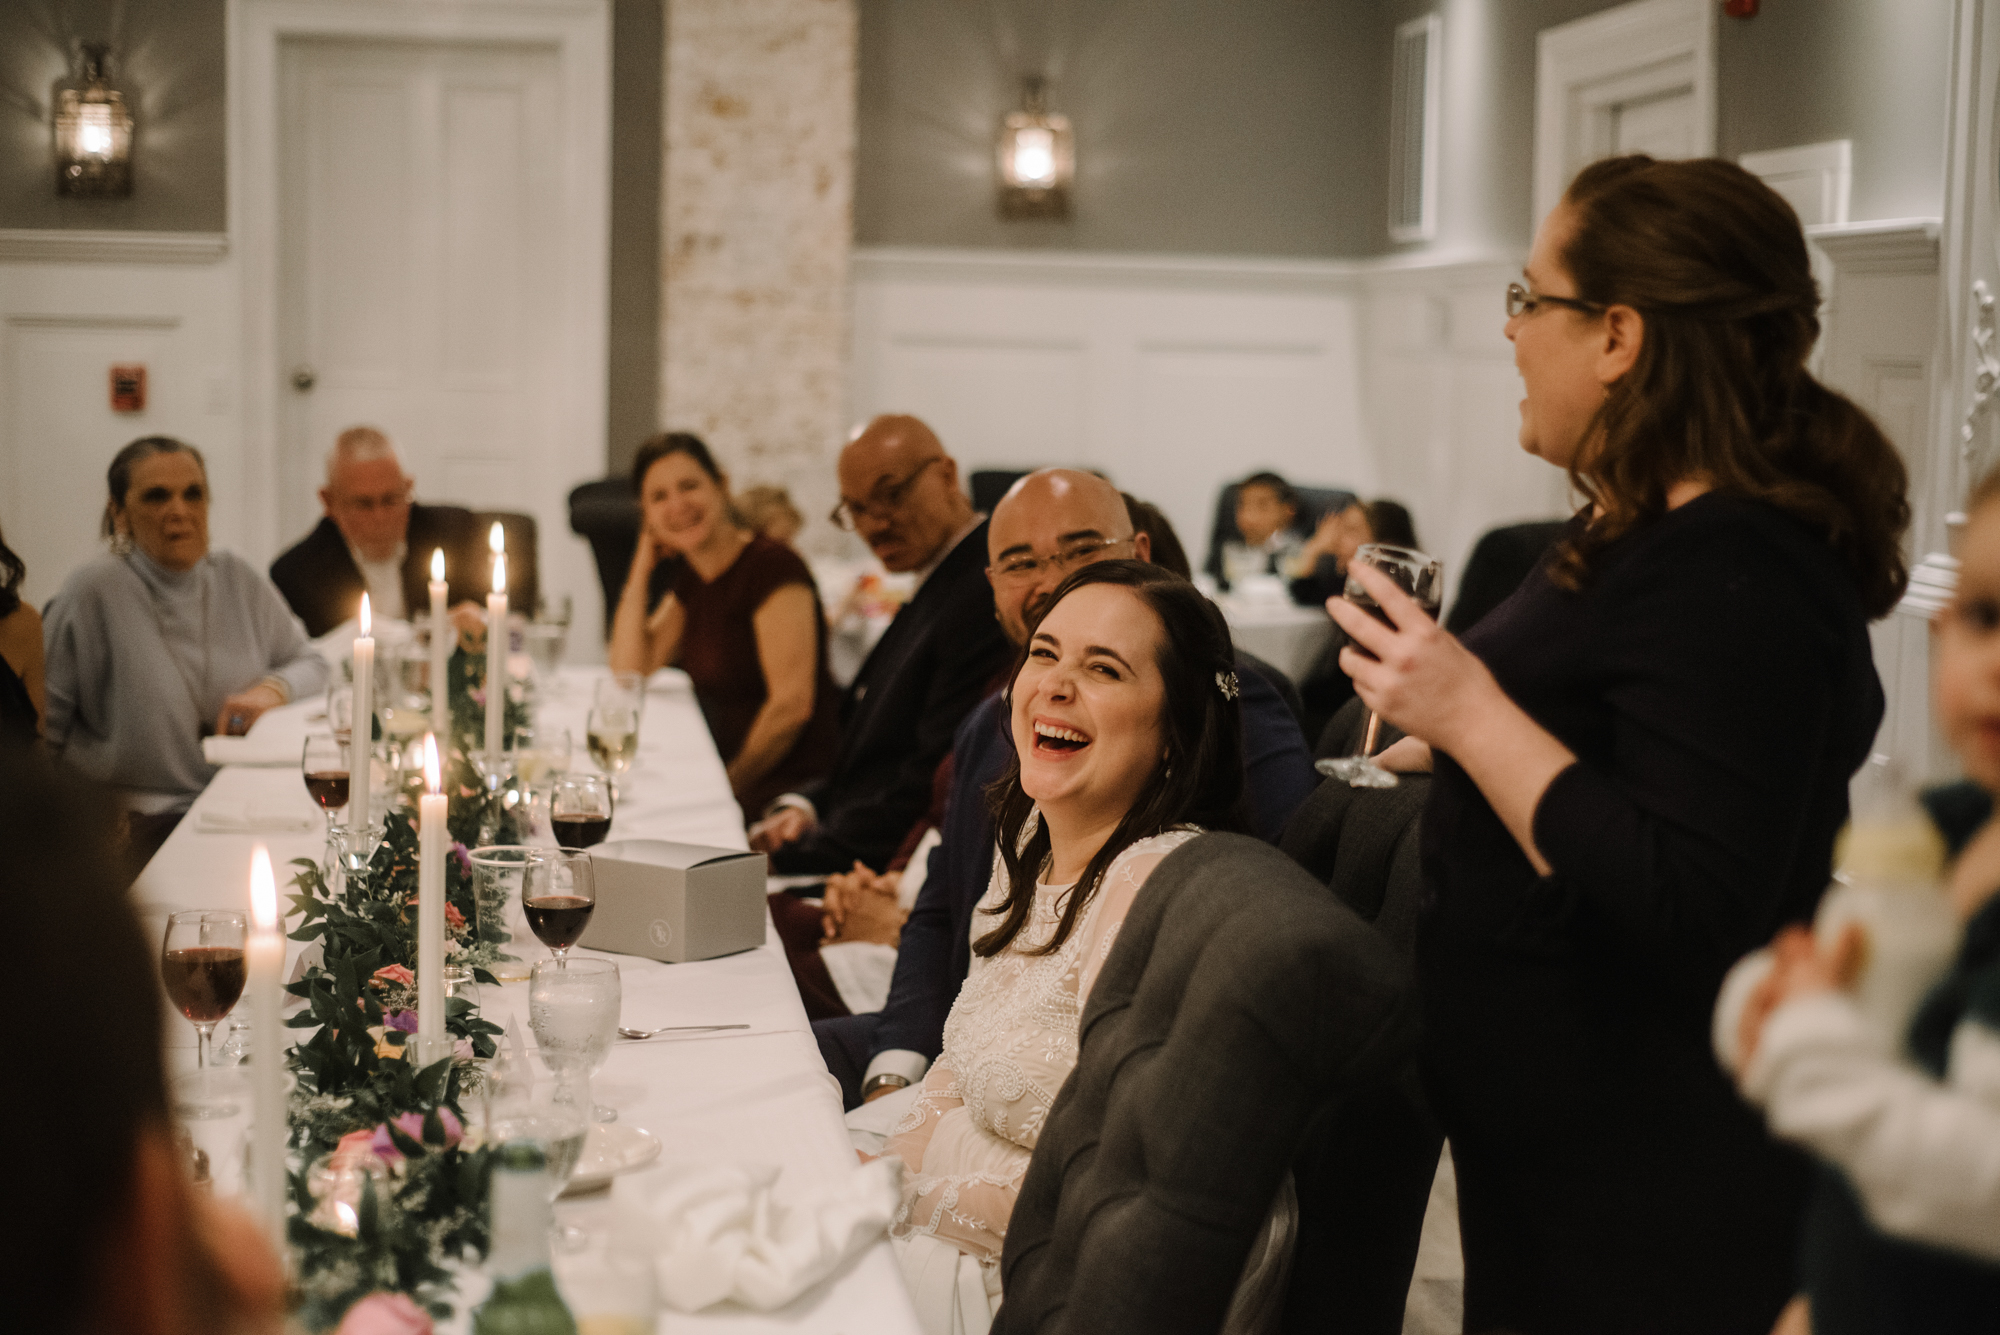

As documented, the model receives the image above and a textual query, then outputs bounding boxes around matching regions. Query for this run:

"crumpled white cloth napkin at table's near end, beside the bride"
[612,1159,902,1311]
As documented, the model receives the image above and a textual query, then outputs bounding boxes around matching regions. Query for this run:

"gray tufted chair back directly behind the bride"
[994,833,1416,1335]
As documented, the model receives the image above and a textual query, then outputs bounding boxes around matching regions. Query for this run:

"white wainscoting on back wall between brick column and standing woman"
[852,250,1568,607]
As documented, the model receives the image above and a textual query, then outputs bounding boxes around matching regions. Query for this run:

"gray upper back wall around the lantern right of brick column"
[854,0,1386,256]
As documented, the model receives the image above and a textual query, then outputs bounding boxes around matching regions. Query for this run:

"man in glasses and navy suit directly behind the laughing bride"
[812,468,1318,1107]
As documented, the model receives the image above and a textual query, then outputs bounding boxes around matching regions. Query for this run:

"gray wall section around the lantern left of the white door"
[0,0,228,232]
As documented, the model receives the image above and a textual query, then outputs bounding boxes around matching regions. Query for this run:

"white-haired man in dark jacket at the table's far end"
[270,426,492,636]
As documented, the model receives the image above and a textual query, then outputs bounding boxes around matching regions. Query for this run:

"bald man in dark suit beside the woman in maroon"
[750,416,1010,875]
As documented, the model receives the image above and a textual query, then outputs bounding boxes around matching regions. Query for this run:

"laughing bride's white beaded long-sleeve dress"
[884,825,1200,1335]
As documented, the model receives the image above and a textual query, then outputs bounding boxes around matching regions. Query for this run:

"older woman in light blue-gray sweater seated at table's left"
[44,436,326,823]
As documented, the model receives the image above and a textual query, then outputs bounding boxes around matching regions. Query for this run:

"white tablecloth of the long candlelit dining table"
[138,668,916,1335]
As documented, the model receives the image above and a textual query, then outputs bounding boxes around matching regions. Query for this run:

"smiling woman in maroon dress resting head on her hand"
[610,432,840,823]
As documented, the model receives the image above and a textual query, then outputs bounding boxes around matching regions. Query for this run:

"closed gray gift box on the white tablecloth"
[578,839,764,963]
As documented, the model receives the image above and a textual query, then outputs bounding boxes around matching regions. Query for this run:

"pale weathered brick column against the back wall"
[660,0,856,544]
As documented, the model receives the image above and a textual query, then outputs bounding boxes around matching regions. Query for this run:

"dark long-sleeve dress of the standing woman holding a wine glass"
[1418,496,1882,1335]
